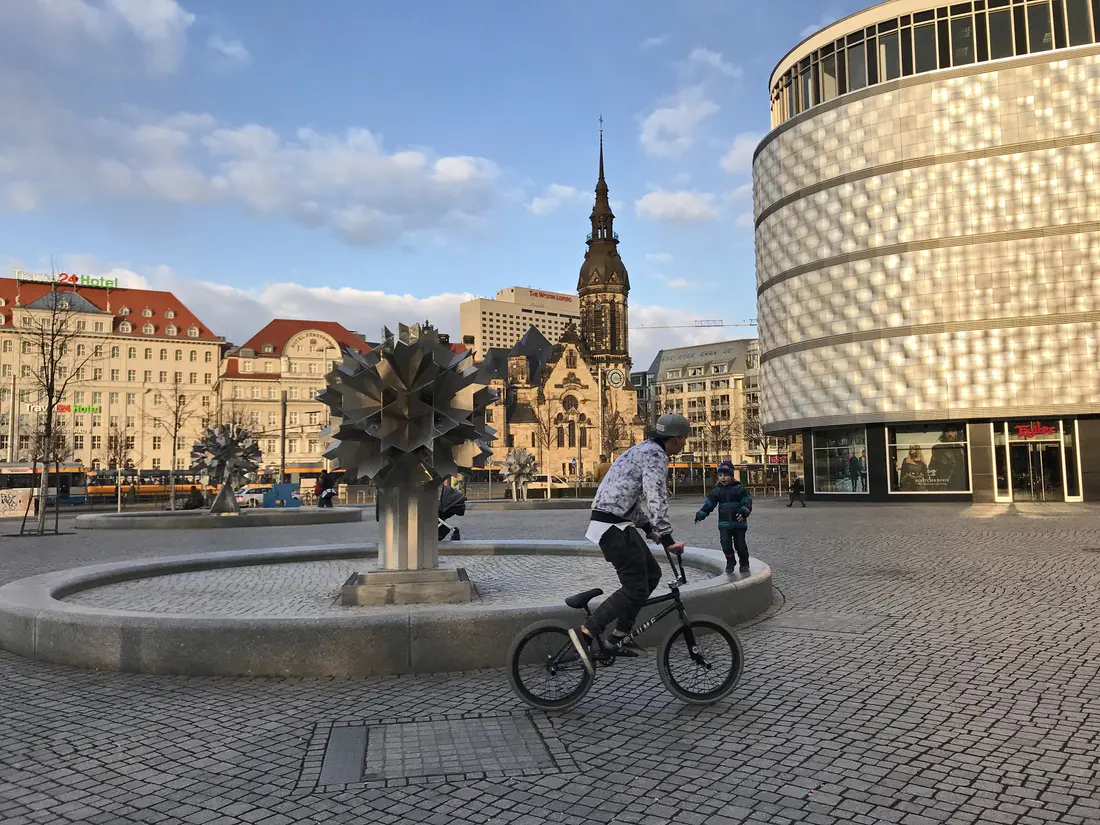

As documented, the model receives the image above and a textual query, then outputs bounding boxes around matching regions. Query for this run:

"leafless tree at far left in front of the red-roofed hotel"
[19,284,102,536]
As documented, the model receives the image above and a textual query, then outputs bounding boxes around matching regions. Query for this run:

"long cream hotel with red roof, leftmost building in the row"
[0,273,224,470]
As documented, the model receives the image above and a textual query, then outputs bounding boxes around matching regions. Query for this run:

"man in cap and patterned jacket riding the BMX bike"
[569,414,691,673]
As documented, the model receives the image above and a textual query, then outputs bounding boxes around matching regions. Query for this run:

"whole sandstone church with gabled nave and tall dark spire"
[482,130,645,482]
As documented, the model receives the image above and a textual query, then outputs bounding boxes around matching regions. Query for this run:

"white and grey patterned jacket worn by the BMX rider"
[592,441,675,547]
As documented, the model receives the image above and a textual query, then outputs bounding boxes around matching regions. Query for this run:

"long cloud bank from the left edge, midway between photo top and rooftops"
[0,78,503,245]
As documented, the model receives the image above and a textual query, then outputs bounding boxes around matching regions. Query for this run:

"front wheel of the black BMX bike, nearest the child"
[657,616,745,705]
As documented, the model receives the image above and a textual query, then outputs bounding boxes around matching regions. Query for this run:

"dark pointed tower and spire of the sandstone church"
[576,127,630,375]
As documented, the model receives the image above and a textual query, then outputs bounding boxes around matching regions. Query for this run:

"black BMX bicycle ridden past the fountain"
[507,550,744,711]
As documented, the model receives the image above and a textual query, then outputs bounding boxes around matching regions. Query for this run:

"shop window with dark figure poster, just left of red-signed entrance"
[888,421,970,493]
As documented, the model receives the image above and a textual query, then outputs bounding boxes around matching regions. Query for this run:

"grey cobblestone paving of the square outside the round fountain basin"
[0,502,1100,825]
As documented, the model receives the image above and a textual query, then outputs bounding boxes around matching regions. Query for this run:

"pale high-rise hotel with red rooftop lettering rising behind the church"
[459,286,581,360]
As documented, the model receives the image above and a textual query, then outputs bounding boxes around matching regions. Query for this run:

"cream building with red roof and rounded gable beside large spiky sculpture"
[218,318,374,479]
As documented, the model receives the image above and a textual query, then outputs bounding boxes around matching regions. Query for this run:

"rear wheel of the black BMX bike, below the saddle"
[507,619,593,711]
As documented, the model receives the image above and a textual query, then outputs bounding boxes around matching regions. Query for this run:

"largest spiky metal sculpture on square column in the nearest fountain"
[318,325,496,570]
